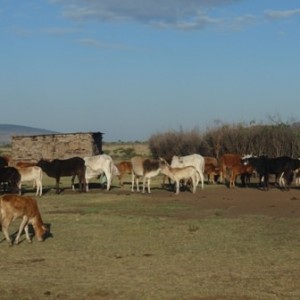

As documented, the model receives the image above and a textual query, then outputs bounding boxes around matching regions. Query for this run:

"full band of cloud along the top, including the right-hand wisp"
[50,0,300,31]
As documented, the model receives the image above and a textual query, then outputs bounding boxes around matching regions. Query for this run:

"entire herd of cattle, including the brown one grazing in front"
[0,153,300,244]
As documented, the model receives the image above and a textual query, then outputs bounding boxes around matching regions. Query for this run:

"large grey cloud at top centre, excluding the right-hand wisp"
[51,0,244,30]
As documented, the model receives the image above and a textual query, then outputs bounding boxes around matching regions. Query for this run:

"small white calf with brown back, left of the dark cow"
[17,166,43,196]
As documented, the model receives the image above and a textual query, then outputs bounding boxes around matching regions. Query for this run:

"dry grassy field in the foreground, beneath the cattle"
[0,172,300,300]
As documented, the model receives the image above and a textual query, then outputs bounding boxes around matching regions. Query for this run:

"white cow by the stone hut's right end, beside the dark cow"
[84,154,114,192]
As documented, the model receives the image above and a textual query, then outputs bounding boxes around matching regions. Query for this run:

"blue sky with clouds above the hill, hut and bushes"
[0,0,300,141]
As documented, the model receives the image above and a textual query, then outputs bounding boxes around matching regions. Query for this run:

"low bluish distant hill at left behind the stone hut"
[0,124,58,145]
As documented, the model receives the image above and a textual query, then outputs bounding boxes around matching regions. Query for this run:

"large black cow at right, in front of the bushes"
[242,156,293,189]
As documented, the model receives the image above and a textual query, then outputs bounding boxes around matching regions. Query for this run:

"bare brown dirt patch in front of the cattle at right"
[112,179,300,219]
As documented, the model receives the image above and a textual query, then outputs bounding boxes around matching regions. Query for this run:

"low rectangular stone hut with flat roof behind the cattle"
[11,132,102,162]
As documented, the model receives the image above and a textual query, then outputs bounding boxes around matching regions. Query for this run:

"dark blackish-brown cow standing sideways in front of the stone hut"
[37,157,86,194]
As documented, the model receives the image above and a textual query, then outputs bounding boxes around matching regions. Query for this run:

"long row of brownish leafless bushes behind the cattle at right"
[149,122,300,160]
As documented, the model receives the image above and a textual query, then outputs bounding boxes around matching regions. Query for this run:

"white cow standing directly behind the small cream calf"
[171,154,205,190]
